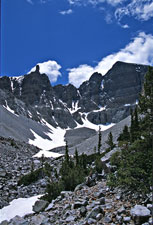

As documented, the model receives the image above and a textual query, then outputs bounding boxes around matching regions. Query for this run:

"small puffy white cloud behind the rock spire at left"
[29,60,61,83]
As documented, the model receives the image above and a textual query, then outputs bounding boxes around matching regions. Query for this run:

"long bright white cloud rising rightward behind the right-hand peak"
[69,32,153,87]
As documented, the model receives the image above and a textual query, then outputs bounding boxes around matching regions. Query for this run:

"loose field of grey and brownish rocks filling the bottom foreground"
[0,175,153,225]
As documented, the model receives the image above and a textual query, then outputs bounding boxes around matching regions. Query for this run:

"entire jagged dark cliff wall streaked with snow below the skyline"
[0,62,148,128]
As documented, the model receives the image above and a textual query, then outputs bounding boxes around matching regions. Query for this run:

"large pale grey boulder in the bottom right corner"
[130,205,150,224]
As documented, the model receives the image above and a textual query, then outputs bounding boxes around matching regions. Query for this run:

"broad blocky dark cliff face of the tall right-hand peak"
[104,62,147,107]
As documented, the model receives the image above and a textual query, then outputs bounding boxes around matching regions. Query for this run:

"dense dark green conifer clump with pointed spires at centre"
[43,142,87,201]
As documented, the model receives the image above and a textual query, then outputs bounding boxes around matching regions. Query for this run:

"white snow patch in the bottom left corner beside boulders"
[0,195,42,223]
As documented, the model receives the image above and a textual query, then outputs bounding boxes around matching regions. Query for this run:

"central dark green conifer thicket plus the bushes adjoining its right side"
[43,142,106,202]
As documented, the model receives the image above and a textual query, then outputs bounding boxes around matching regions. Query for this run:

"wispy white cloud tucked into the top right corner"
[115,0,153,21]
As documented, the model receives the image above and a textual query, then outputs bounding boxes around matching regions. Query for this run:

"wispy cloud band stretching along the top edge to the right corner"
[67,0,153,24]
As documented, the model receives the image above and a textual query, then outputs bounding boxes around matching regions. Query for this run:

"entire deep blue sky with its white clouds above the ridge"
[1,0,153,87]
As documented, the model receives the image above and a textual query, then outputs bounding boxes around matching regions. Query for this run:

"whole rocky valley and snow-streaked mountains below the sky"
[0,61,153,225]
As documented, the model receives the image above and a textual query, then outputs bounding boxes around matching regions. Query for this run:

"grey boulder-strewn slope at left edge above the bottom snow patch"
[0,137,60,209]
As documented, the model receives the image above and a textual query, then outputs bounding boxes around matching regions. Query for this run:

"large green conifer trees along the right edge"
[108,67,153,193]
